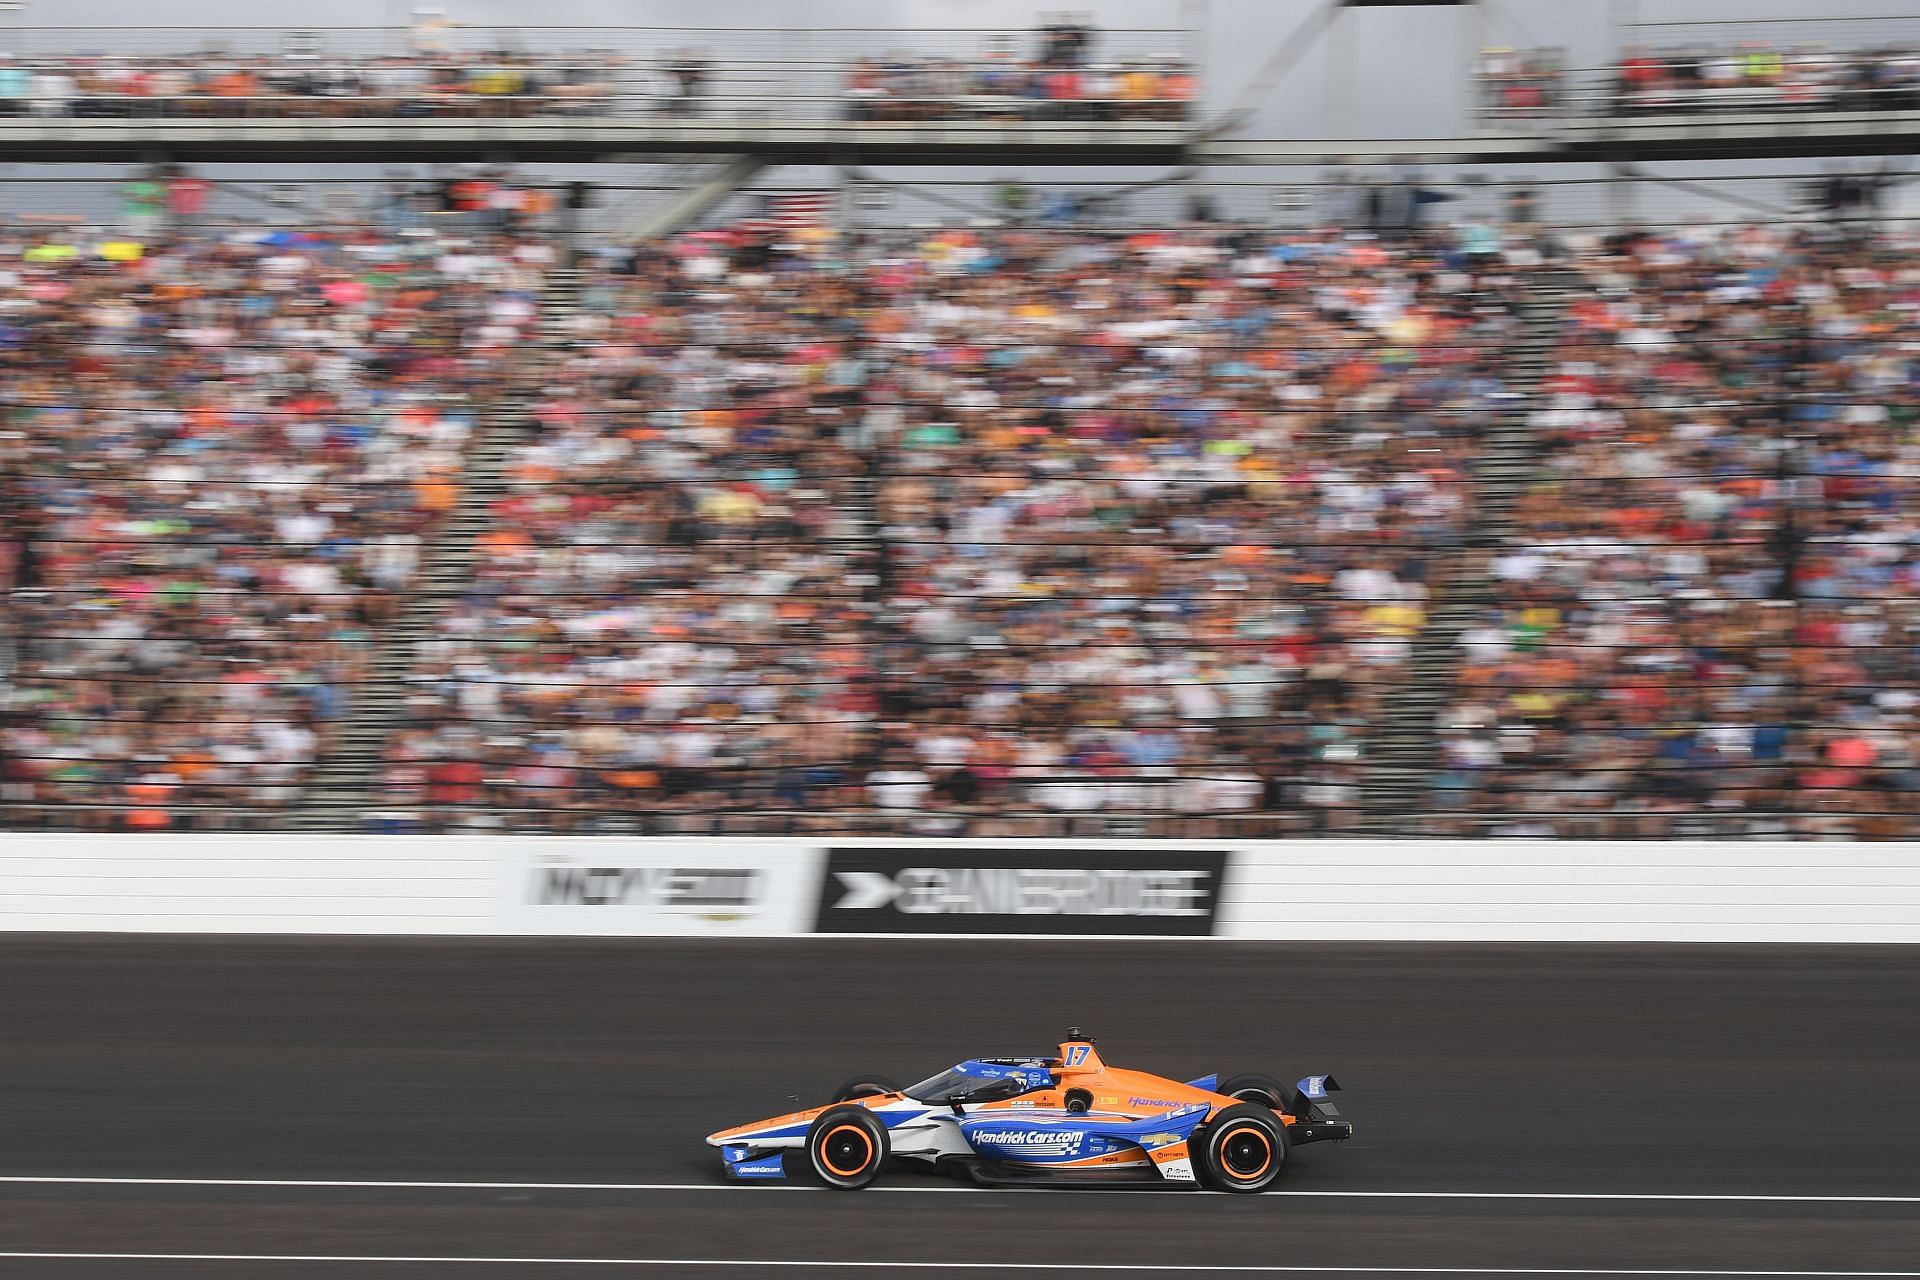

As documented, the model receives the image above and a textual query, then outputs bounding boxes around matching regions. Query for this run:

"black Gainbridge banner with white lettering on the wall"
[816,844,1227,936]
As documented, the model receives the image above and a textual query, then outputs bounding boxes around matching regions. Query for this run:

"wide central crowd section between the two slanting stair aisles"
[374,230,1515,833]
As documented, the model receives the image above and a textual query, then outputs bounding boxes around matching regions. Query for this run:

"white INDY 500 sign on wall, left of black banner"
[497,839,820,936]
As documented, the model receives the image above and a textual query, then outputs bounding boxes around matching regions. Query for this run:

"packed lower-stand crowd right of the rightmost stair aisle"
[1434,228,1920,837]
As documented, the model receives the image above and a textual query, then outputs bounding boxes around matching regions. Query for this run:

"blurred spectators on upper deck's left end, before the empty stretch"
[0,50,629,119]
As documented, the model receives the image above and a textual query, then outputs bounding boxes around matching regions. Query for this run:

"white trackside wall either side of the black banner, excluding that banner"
[0,833,1920,942]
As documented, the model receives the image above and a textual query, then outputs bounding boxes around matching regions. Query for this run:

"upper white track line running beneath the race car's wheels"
[0,1174,1920,1205]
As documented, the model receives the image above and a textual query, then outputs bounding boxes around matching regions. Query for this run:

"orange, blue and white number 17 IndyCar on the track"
[707,1027,1354,1192]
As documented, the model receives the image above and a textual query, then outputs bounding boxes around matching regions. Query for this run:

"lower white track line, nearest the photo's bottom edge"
[0,1251,1920,1280]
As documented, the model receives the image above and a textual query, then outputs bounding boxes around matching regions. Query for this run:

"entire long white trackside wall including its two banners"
[0,831,1920,944]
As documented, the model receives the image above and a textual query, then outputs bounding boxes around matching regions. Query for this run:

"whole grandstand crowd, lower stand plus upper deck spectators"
[0,20,1920,839]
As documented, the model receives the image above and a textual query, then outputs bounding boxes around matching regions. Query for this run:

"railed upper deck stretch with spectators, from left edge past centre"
[0,27,1196,121]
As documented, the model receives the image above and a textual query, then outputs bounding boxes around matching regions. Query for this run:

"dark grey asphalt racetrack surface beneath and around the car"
[0,936,1920,1280]
